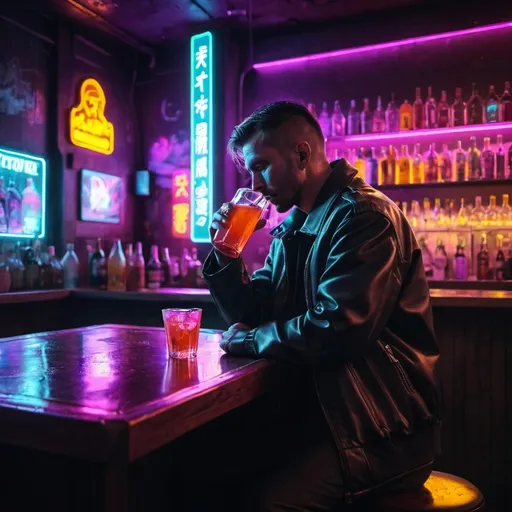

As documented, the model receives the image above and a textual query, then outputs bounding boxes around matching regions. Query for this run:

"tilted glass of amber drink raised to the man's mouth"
[213,188,268,258]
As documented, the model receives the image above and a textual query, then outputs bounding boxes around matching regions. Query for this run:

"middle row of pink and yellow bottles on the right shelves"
[328,135,512,185]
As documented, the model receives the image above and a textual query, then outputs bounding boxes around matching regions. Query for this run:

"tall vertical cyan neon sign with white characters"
[190,32,214,243]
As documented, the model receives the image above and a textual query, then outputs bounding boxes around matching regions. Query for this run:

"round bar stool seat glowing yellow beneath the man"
[365,471,485,512]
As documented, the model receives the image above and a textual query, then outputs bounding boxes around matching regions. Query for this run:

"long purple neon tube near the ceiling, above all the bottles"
[253,21,512,70]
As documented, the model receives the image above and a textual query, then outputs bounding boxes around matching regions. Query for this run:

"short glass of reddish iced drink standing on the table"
[162,308,202,359]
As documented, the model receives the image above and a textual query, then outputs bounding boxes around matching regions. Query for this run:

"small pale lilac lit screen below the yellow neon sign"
[80,169,123,224]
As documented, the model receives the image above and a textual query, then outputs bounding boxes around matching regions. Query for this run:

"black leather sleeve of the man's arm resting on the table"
[244,212,402,362]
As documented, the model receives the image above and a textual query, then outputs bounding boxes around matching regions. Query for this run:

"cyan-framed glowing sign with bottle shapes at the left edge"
[0,148,46,238]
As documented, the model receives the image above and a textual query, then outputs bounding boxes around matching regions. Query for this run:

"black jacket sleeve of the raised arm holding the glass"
[203,242,274,327]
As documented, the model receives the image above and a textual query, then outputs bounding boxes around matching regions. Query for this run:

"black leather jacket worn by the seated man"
[204,160,440,501]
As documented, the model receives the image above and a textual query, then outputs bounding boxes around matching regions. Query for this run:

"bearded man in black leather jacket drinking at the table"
[204,101,440,512]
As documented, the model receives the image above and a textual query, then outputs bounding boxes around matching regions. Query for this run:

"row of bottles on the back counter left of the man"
[0,239,205,292]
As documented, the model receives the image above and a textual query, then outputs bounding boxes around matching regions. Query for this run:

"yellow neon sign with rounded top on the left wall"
[69,78,114,155]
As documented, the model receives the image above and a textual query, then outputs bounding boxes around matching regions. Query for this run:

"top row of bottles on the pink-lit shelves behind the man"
[308,82,512,138]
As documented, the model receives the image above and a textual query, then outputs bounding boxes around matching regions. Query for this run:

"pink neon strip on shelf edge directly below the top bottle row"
[338,122,512,144]
